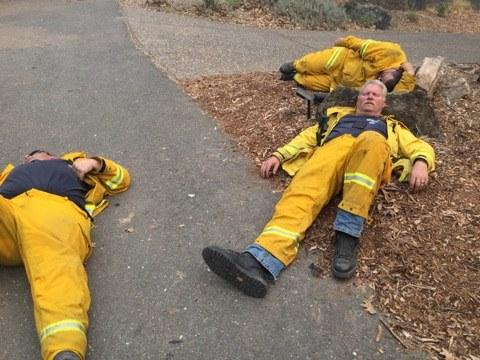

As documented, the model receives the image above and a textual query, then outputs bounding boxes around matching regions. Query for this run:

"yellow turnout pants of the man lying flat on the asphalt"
[0,190,91,360]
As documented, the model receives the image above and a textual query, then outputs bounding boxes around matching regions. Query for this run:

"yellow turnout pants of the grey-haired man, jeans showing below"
[255,131,391,266]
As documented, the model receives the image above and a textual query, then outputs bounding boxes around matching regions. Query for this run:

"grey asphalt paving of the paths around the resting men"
[0,0,479,360]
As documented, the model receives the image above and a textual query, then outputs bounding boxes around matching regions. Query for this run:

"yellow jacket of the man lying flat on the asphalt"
[0,152,130,217]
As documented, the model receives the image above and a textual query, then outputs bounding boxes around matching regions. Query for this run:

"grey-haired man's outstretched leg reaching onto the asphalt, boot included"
[202,136,353,297]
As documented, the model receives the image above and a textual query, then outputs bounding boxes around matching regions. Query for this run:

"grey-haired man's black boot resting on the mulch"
[332,231,358,279]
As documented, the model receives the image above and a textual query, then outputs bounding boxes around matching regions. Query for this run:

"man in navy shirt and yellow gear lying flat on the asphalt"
[0,150,130,360]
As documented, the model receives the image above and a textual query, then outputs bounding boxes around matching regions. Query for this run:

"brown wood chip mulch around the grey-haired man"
[181,65,480,360]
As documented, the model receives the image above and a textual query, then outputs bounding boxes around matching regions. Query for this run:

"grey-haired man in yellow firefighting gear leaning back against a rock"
[202,80,435,297]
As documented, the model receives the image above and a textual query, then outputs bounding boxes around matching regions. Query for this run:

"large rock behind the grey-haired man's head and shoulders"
[318,86,441,137]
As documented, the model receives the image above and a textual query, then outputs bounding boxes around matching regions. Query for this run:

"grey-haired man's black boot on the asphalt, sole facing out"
[202,246,269,298]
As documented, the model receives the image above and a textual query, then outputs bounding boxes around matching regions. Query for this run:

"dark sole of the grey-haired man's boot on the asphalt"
[202,246,267,298]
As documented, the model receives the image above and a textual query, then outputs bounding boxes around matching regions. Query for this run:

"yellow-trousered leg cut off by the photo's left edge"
[0,195,22,266]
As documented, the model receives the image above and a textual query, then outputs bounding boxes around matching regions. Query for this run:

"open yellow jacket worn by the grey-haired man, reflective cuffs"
[273,106,435,181]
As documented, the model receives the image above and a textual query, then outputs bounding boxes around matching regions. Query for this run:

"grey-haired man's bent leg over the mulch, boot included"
[332,131,390,278]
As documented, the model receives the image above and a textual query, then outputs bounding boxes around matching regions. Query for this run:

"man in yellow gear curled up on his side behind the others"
[280,36,415,92]
